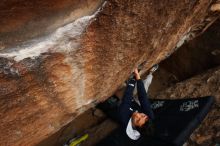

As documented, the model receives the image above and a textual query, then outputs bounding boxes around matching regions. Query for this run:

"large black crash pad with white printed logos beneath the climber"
[97,96,214,146]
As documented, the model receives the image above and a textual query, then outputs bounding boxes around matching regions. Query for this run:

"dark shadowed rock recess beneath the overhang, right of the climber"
[149,19,220,96]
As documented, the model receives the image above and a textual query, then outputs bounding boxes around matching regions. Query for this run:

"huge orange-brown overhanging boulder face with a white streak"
[0,0,217,145]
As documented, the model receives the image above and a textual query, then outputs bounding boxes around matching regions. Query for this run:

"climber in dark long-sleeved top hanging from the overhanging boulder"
[96,65,158,143]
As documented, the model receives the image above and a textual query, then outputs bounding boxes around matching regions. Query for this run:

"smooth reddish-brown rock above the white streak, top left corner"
[0,0,102,50]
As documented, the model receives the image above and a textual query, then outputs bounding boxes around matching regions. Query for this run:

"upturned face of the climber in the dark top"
[132,111,149,128]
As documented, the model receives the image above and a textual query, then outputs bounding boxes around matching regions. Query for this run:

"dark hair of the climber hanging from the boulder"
[136,120,155,136]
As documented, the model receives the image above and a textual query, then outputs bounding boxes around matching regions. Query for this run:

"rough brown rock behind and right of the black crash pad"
[156,67,220,146]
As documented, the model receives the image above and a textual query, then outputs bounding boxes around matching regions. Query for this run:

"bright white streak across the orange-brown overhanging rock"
[0,2,106,61]
